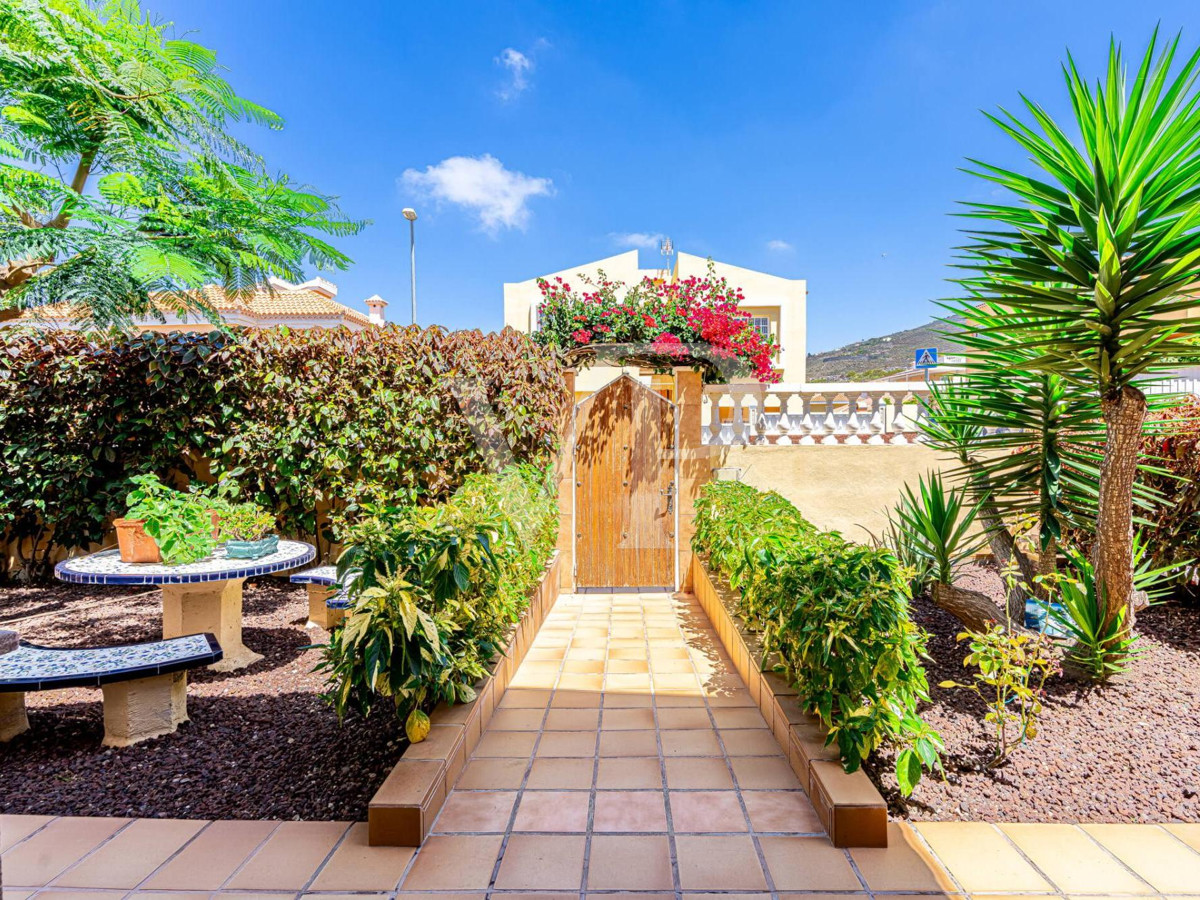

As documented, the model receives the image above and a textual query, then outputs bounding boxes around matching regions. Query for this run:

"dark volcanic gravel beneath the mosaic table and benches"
[0,577,406,821]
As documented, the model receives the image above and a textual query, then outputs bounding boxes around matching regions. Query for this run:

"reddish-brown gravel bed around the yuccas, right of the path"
[866,564,1200,822]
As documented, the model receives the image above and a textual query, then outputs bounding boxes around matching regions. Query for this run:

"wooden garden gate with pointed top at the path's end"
[575,374,678,589]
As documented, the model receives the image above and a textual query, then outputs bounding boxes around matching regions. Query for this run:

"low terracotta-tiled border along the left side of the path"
[367,551,563,847]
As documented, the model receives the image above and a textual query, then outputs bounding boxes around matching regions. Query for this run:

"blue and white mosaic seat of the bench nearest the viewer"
[0,635,223,692]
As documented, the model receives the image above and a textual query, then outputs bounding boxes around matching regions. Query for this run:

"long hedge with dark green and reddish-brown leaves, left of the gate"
[0,326,569,577]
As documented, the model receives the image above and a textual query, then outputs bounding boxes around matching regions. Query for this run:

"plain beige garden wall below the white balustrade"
[709,444,954,544]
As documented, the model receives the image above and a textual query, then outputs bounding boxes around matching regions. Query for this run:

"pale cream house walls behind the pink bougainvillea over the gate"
[504,250,808,391]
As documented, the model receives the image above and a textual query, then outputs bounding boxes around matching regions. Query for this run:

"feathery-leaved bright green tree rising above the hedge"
[0,0,362,325]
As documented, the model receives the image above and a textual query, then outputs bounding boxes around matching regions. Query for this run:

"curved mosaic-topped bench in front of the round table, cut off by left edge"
[0,631,223,746]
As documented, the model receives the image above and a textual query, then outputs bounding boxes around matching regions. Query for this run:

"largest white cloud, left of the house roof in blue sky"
[400,154,554,238]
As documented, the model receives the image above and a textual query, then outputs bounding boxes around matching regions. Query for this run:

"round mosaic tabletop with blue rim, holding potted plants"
[54,541,317,584]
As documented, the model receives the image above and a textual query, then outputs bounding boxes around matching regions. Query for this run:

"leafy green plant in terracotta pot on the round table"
[114,475,216,565]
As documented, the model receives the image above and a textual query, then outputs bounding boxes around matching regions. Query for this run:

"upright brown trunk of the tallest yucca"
[1092,385,1146,630]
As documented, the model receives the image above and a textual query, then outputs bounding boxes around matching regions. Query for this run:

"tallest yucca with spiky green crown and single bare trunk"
[962,34,1200,622]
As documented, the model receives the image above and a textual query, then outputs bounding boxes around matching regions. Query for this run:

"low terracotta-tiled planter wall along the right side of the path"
[691,556,888,847]
